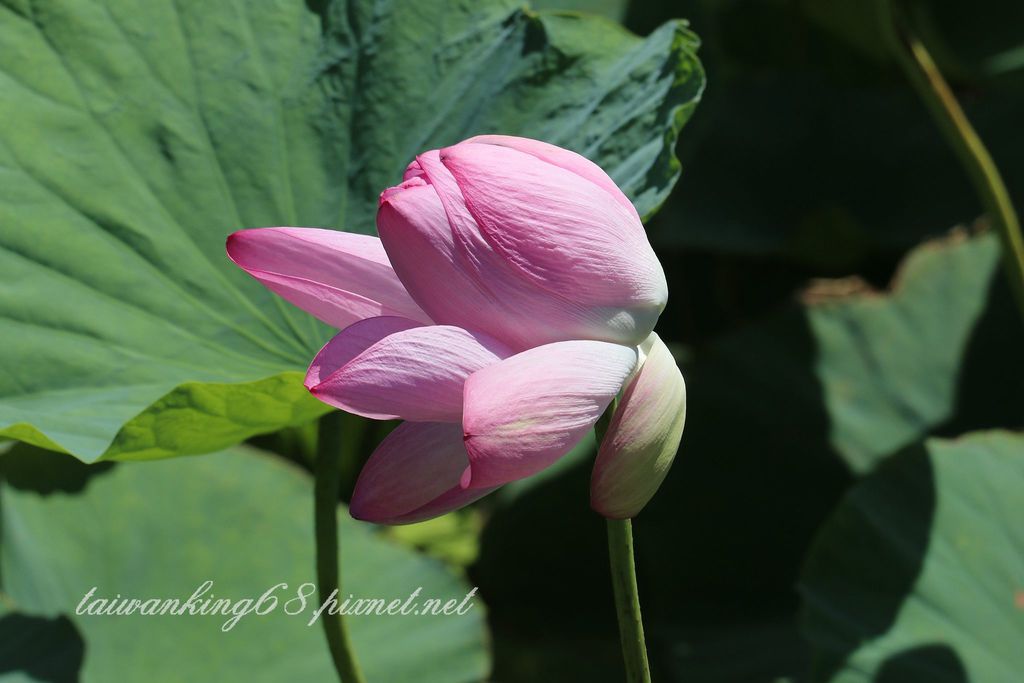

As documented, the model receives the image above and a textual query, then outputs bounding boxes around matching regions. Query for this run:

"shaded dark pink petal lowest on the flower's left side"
[349,422,494,524]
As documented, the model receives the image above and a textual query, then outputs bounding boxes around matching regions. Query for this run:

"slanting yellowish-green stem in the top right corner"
[883,0,1024,316]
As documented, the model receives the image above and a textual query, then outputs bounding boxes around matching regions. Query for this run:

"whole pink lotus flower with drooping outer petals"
[227,135,685,523]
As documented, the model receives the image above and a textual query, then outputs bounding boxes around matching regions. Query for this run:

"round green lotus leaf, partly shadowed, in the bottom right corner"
[801,431,1024,683]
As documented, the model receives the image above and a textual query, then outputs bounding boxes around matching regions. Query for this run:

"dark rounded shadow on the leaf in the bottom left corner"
[0,613,85,683]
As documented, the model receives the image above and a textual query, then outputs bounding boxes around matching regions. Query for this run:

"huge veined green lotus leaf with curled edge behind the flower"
[0,0,703,461]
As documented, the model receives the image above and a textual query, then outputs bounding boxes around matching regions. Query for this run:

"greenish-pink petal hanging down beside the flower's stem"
[590,334,686,519]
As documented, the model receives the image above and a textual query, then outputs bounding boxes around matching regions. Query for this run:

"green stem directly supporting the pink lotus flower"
[594,398,650,683]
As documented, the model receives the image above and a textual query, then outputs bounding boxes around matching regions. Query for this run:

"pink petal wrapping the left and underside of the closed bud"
[377,151,635,349]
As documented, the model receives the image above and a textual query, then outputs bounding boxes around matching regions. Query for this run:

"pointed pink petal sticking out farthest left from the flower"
[227,227,430,329]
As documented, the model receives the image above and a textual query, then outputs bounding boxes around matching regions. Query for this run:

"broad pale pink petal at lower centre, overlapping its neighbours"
[462,341,637,488]
